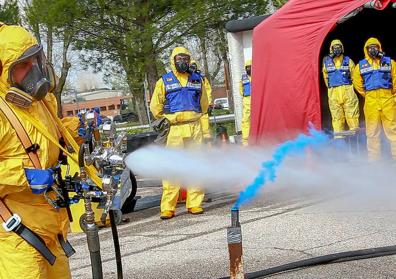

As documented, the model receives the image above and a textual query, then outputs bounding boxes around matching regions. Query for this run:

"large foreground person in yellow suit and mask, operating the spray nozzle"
[0,23,85,279]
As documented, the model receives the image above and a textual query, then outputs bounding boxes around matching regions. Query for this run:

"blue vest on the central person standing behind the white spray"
[162,72,202,113]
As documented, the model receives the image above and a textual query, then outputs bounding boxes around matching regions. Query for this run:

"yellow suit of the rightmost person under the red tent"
[352,38,396,160]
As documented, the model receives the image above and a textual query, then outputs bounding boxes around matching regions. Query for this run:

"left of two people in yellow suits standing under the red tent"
[322,40,359,138]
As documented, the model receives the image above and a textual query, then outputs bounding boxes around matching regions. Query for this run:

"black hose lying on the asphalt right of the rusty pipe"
[220,245,396,279]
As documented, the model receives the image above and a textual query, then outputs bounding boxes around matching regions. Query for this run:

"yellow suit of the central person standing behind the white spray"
[150,47,208,212]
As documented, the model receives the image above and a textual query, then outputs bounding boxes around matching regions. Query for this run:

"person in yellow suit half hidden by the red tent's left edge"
[240,60,252,146]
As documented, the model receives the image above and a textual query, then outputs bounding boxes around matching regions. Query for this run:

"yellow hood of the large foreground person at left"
[0,23,38,96]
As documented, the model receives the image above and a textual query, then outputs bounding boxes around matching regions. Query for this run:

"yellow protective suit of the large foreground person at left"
[0,25,78,279]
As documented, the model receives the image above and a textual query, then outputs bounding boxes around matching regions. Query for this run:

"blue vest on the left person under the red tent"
[324,56,352,87]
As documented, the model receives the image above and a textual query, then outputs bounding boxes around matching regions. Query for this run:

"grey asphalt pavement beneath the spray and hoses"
[70,187,396,279]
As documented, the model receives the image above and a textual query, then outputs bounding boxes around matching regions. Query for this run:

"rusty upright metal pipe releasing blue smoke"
[227,208,245,279]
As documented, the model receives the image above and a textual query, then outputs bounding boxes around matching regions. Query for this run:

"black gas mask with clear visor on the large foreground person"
[6,45,51,108]
